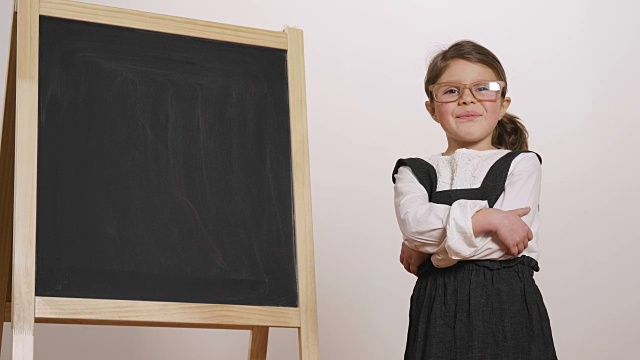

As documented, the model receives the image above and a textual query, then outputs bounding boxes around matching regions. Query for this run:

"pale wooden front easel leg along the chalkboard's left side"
[11,0,40,354]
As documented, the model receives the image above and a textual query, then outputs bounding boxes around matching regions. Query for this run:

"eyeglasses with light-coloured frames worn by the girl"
[429,81,506,103]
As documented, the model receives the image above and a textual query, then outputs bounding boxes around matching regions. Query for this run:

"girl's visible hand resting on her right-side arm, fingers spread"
[472,207,533,256]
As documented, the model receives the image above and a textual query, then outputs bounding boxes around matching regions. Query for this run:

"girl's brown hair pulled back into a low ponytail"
[424,40,529,150]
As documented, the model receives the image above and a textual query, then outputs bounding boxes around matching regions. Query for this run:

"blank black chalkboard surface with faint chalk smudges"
[36,16,298,307]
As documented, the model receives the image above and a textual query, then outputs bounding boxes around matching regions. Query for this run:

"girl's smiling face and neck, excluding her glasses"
[425,59,511,155]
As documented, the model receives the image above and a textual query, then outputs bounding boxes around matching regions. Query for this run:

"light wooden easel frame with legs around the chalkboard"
[0,0,319,360]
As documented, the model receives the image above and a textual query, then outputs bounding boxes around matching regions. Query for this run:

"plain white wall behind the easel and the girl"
[0,0,640,360]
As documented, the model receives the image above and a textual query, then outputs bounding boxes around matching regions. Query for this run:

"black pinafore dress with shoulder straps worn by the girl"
[392,151,557,360]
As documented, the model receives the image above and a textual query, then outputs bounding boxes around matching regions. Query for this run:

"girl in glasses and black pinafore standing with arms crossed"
[393,41,557,360]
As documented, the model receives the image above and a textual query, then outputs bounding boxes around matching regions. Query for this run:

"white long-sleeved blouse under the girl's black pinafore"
[394,149,542,268]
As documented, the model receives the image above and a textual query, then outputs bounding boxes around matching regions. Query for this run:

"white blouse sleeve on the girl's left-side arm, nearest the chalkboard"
[394,166,488,254]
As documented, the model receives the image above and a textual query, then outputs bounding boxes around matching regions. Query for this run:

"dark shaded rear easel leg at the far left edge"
[0,9,16,353]
